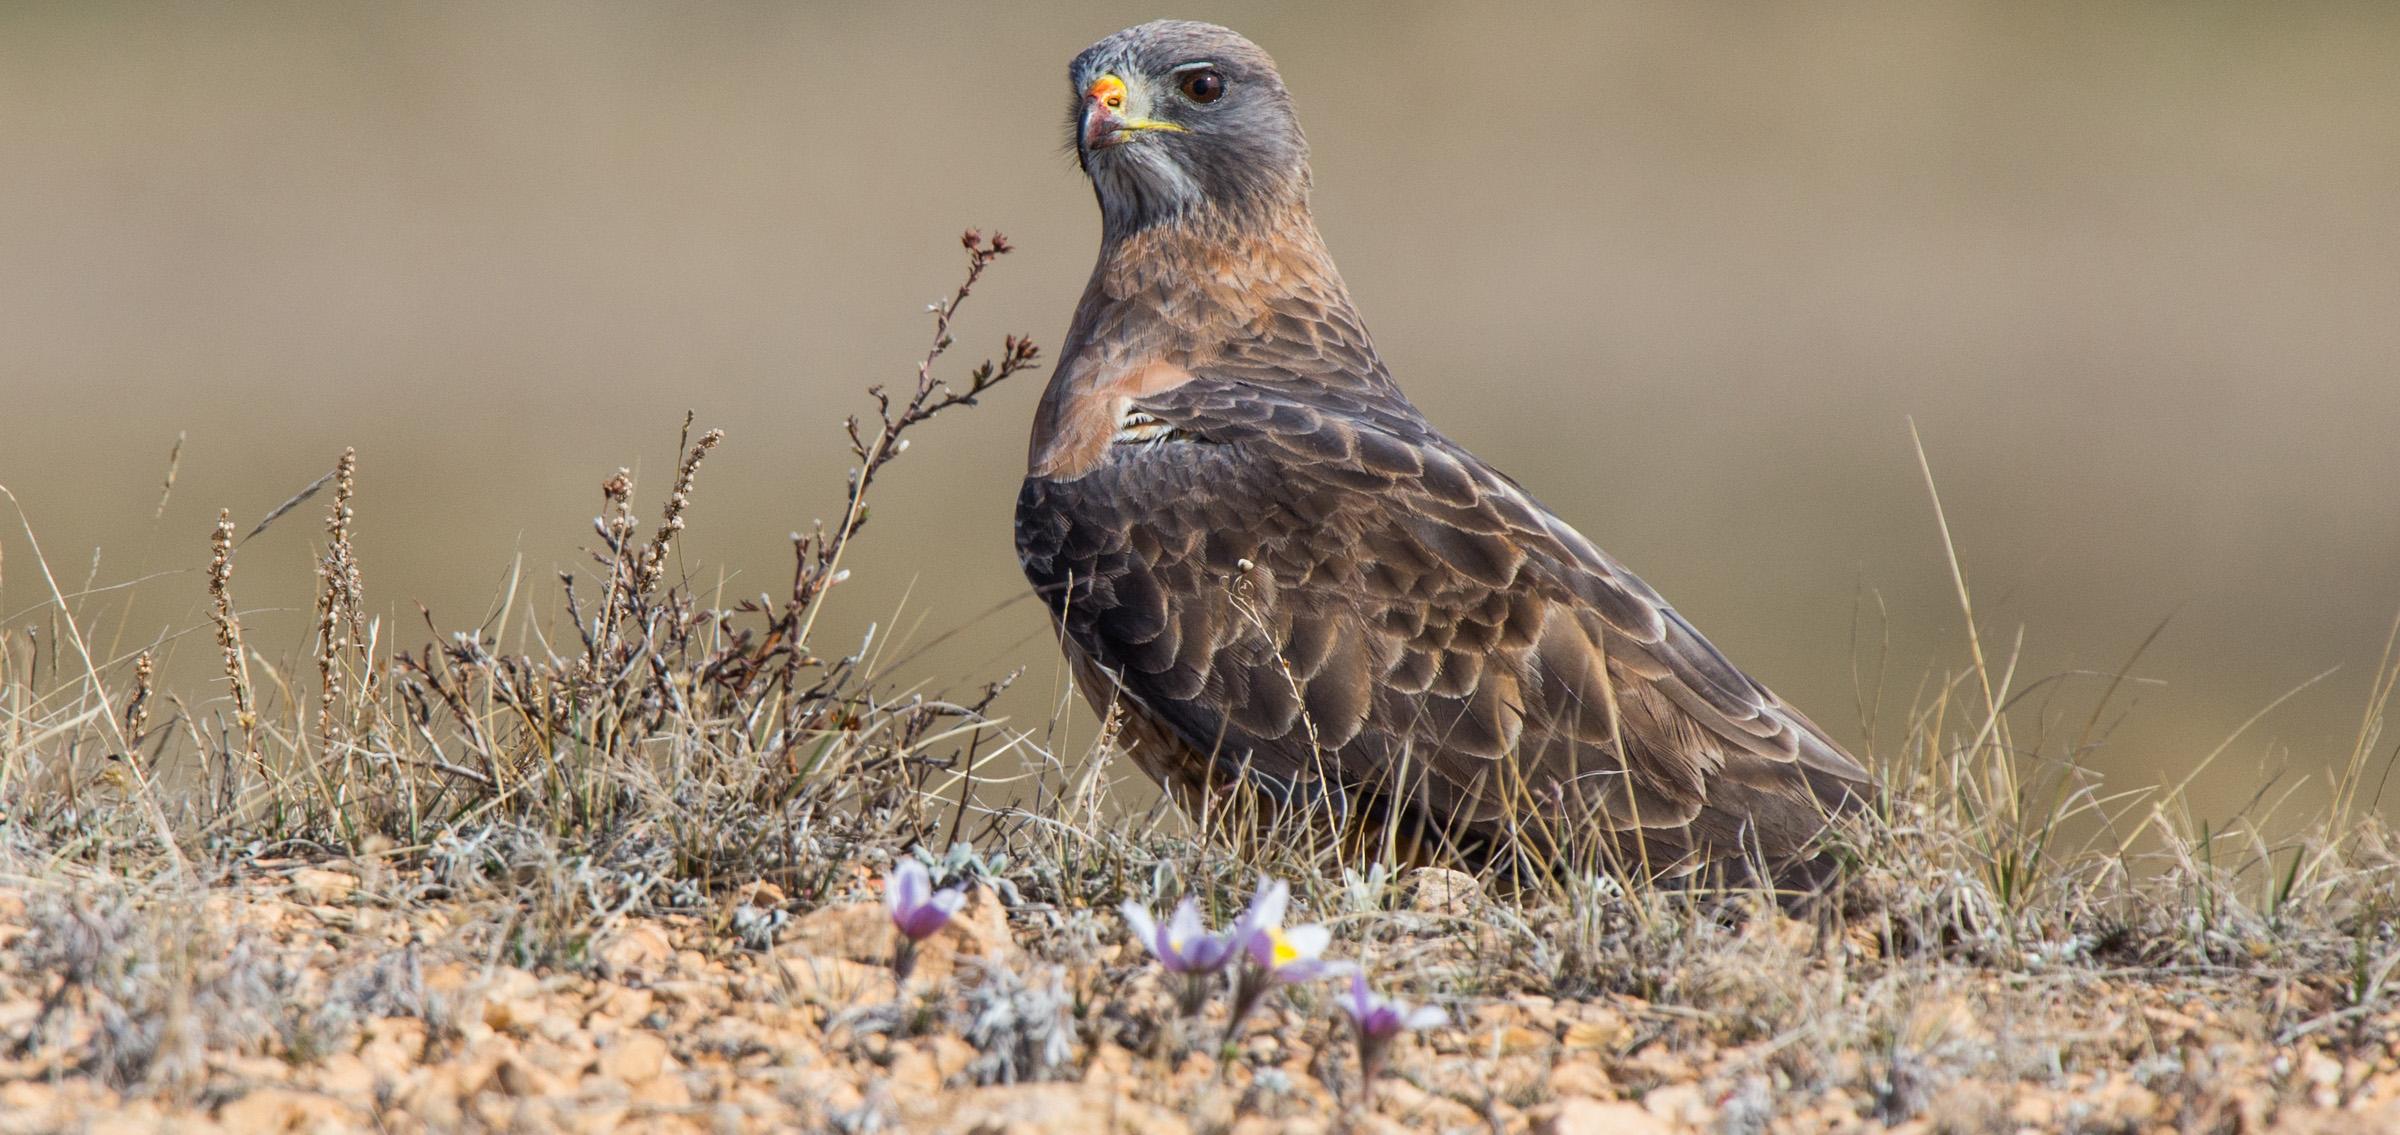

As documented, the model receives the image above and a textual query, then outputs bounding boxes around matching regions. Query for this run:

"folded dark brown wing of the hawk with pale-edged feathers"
[1018,374,1867,873]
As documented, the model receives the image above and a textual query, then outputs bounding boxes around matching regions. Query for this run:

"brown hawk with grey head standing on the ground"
[1015,22,1870,888]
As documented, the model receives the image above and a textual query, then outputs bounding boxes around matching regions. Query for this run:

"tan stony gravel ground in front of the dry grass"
[0,861,2400,1135]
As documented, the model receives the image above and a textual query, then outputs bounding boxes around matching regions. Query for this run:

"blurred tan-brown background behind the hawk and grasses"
[0,0,2400,811]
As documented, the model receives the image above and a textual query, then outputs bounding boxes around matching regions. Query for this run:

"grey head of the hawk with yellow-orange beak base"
[1068,19,1308,235]
